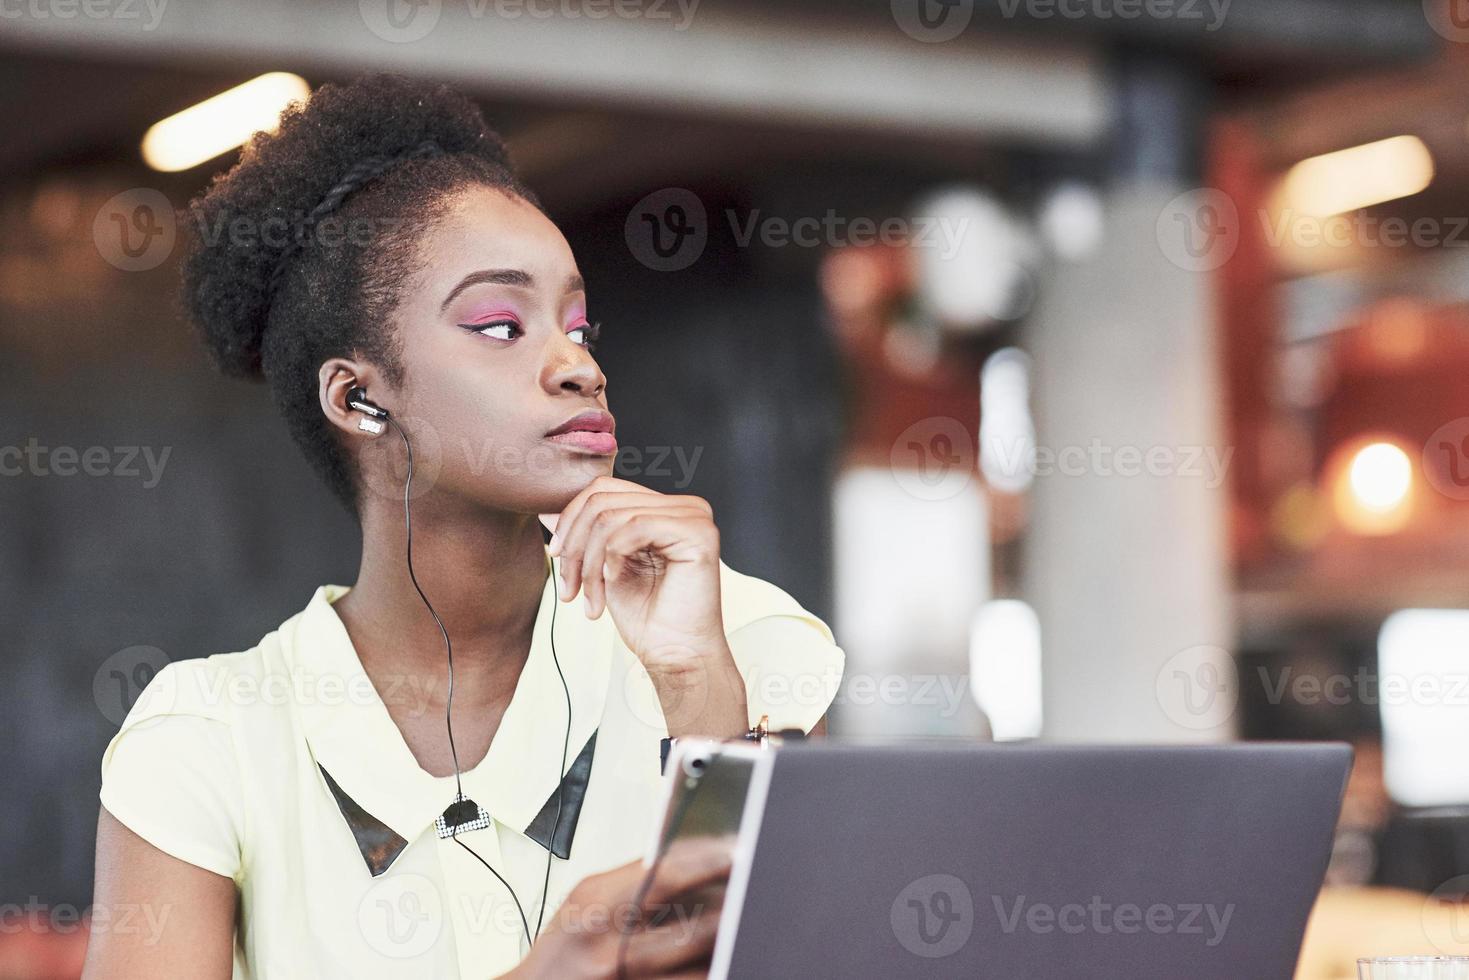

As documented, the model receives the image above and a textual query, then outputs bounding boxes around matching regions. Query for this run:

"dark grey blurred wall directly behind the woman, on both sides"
[0,170,839,907]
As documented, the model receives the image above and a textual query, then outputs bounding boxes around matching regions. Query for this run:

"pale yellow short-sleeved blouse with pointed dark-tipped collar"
[101,560,845,979]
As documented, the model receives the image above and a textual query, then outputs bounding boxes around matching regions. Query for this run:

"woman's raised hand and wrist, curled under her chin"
[549,476,749,738]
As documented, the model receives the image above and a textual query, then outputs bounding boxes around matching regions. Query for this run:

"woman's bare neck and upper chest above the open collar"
[333,504,548,714]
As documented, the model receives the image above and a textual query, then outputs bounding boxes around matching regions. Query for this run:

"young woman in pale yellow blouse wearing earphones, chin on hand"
[85,76,843,980]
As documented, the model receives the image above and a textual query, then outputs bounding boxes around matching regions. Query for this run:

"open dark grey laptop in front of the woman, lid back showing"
[710,742,1351,980]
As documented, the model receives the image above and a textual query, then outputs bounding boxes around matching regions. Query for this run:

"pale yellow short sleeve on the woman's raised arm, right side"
[720,566,846,732]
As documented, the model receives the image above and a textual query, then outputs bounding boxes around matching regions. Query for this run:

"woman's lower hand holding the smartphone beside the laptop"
[502,837,733,980]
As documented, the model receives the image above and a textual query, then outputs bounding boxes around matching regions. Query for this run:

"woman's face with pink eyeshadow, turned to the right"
[378,187,617,514]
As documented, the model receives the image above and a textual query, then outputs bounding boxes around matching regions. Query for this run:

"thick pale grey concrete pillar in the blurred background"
[1024,59,1237,742]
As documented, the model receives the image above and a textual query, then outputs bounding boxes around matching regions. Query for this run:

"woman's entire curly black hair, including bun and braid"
[181,73,541,516]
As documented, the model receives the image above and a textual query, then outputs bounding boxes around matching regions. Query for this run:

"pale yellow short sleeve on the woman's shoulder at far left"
[100,661,244,880]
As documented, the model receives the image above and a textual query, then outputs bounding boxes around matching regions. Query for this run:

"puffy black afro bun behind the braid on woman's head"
[182,73,513,378]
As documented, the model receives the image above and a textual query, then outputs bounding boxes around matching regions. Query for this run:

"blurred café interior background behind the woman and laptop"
[0,0,1469,979]
